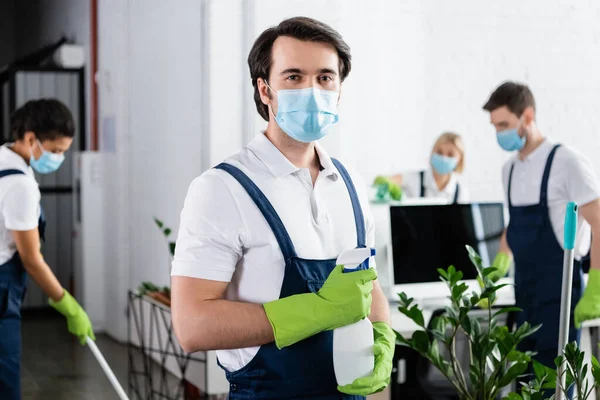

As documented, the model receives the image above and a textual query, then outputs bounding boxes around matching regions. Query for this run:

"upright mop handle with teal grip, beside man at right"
[556,202,577,400]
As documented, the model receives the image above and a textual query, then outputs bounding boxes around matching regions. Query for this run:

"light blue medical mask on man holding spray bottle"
[265,81,339,143]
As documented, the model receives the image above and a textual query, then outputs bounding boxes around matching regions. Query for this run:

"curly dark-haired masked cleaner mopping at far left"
[0,99,94,400]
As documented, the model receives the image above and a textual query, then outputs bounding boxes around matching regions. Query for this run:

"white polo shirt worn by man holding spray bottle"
[171,134,375,371]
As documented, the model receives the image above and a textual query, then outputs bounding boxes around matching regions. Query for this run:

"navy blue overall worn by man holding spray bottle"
[216,159,366,400]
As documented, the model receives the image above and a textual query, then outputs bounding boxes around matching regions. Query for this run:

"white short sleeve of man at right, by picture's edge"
[563,148,600,207]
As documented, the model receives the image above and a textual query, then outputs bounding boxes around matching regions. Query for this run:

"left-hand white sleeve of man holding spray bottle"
[171,170,245,282]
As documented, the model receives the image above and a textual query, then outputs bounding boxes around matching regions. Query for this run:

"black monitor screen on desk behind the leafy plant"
[390,203,504,285]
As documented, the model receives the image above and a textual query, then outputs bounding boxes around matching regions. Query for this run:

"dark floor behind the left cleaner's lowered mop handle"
[18,315,389,400]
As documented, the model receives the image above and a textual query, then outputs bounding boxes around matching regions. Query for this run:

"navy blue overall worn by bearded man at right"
[507,145,583,368]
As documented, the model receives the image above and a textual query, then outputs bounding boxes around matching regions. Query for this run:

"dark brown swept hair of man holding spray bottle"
[248,17,351,121]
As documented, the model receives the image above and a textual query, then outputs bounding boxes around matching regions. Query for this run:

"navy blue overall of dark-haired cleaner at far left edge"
[0,169,46,400]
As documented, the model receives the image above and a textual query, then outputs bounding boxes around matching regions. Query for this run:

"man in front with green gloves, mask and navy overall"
[172,18,395,400]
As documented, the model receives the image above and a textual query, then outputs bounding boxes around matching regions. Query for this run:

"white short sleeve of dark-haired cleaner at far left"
[2,177,41,231]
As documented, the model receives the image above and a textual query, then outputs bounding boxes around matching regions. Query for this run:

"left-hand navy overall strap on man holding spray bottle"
[215,163,296,261]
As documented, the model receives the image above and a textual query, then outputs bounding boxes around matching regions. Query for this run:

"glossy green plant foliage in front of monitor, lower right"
[396,246,600,400]
